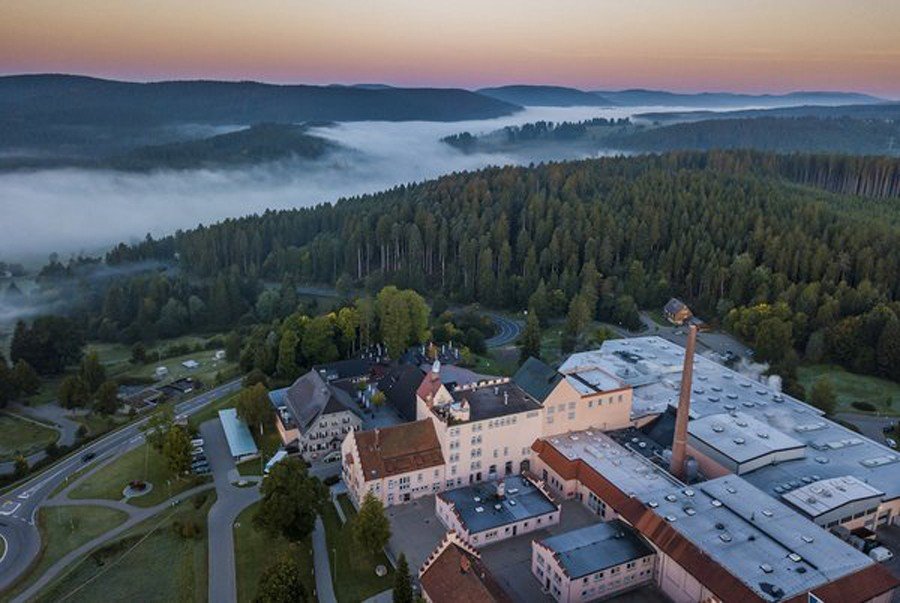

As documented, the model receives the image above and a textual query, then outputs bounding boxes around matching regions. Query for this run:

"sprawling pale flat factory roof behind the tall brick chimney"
[576,336,900,500]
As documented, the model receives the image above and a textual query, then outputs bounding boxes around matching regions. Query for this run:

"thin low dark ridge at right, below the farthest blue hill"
[634,102,900,123]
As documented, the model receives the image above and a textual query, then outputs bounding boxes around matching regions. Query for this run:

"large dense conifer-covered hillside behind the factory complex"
[98,153,900,378]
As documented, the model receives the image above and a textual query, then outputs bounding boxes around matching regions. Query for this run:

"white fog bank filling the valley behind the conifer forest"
[0,107,712,260]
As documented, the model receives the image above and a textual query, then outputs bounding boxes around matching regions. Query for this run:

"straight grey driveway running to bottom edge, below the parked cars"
[200,419,260,603]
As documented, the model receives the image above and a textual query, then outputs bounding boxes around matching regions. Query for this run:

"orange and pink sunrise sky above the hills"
[0,0,900,98]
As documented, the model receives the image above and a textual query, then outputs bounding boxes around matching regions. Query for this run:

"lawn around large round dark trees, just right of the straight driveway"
[234,503,316,603]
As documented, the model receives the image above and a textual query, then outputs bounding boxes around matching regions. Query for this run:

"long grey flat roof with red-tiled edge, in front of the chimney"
[545,431,873,600]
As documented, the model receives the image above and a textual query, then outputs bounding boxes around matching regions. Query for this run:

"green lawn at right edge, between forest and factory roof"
[797,364,900,415]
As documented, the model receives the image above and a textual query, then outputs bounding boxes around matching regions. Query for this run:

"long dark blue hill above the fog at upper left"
[0,75,520,157]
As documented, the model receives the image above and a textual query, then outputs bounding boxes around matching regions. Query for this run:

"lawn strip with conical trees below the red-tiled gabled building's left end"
[322,494,394,602]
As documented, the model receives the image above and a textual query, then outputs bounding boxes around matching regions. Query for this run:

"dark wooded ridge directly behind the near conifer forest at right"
[608,117,900,160]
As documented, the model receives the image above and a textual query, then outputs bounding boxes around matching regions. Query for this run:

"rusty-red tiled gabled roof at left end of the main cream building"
[353,418,444,481]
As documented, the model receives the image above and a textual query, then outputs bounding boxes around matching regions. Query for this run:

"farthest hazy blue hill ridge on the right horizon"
[593,89,884,108]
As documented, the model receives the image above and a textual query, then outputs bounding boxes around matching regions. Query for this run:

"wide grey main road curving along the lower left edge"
[0,379,241,592]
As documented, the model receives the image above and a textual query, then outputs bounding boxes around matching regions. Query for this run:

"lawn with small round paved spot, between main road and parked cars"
[69,444,207,507]
